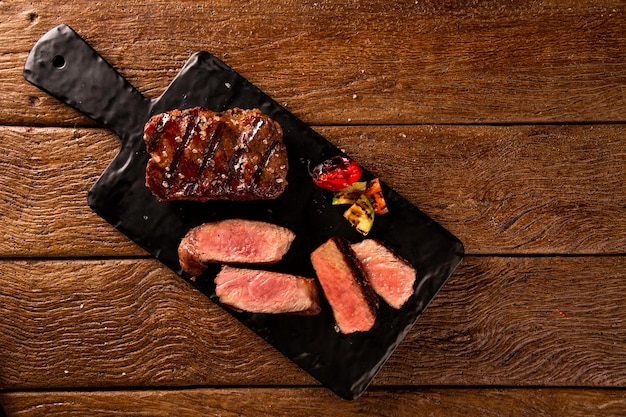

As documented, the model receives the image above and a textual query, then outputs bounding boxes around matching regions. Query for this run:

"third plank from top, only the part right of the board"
[378,257,626,387]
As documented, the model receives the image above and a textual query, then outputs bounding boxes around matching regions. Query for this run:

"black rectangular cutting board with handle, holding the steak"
[24,25,463,399]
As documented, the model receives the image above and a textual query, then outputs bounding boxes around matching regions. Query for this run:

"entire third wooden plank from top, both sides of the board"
[0,257,626,390]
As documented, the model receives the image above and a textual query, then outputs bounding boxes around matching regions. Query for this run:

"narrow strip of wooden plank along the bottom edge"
[0,388,626,417]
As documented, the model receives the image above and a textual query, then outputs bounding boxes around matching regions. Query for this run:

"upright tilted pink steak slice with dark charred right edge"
[311,238,378,334]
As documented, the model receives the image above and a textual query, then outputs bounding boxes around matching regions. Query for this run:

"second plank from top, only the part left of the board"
[0,127,139,257]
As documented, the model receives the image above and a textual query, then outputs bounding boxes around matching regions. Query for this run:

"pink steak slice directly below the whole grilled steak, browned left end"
[178,219,296,275]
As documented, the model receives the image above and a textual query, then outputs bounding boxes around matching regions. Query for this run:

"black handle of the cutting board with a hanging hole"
[24,25,151,141]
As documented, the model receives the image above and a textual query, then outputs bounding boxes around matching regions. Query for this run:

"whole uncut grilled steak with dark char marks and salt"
[144,107,288,201]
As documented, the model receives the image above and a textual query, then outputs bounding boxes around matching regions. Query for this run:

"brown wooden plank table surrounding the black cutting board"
[0,0,626,416]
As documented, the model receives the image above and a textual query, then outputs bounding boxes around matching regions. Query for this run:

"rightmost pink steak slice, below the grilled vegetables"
[352,239,416,309]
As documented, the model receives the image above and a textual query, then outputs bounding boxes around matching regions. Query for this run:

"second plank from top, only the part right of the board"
[319,125,626,254]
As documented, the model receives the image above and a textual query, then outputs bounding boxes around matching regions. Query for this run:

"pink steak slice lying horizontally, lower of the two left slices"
[215,266,321,315]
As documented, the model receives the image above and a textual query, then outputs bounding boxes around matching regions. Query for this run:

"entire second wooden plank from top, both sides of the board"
[0,125,626,257]
